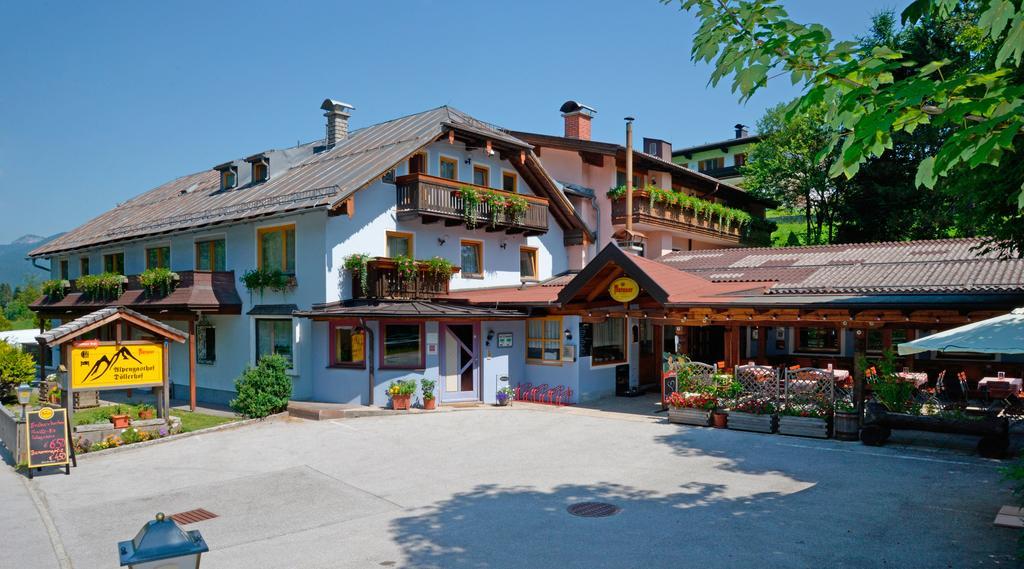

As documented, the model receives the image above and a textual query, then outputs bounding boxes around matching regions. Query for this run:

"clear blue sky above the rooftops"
[0,0,903,243]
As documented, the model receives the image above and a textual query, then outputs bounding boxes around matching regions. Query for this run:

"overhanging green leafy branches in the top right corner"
[664,0,1024,252]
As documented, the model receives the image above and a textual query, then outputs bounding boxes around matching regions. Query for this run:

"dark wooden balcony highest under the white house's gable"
[395,174,548,235]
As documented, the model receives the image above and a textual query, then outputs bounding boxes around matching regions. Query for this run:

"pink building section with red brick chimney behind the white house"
[511,100,772,260]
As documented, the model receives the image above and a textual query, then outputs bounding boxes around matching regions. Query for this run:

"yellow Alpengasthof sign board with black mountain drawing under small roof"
[71,344,164,389]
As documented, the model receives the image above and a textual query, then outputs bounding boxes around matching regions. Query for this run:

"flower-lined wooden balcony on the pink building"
[611,189,743,245]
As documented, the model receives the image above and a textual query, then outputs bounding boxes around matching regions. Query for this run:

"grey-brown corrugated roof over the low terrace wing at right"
[658,238,1024,295]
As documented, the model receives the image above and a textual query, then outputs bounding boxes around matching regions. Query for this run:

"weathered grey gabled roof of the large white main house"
[29,106,583,257]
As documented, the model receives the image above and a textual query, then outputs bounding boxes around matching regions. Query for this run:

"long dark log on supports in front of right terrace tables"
[860,401,1010,458]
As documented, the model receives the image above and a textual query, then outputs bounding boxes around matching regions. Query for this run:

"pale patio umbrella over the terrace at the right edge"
[899,308,1024,355]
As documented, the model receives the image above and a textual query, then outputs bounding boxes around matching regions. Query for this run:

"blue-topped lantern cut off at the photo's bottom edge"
[118,513,210,569]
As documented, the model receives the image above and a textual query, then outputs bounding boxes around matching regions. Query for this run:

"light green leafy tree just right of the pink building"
[740,104,839,245]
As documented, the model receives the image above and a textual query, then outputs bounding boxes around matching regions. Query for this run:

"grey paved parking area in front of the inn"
[9,407,1017,569]
